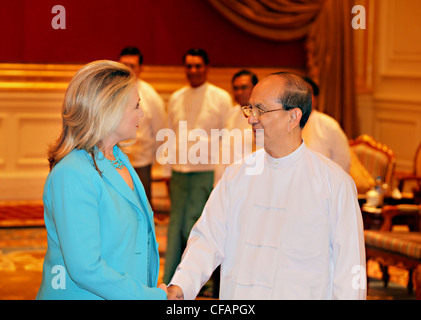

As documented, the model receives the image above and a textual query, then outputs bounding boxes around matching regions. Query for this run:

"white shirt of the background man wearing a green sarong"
[168,82,232,172]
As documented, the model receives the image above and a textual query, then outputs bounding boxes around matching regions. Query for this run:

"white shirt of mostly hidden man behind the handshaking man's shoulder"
[303,110,351,172]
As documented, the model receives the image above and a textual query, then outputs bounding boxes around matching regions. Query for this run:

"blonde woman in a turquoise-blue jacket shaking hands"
[37,61,166,300]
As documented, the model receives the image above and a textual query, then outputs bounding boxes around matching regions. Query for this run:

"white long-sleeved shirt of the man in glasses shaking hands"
[171,143,366,300]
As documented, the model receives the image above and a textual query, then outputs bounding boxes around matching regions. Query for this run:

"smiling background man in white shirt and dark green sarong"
[164,48,232,283]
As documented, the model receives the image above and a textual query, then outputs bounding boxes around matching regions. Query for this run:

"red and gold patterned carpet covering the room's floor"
[0,203,415,300]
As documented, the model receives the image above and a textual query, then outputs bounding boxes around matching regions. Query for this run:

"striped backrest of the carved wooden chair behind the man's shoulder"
[349,135,396,186]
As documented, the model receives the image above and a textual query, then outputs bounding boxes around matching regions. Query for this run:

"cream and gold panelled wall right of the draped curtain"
[372,0,421,170]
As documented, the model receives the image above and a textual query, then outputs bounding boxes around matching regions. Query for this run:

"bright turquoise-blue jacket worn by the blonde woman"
[37,146,166,300]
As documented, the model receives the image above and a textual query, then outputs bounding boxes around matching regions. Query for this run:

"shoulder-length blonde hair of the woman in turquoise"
[48,60,136,172]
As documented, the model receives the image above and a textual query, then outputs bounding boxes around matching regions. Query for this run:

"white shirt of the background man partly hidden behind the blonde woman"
[126,79,166,168]
